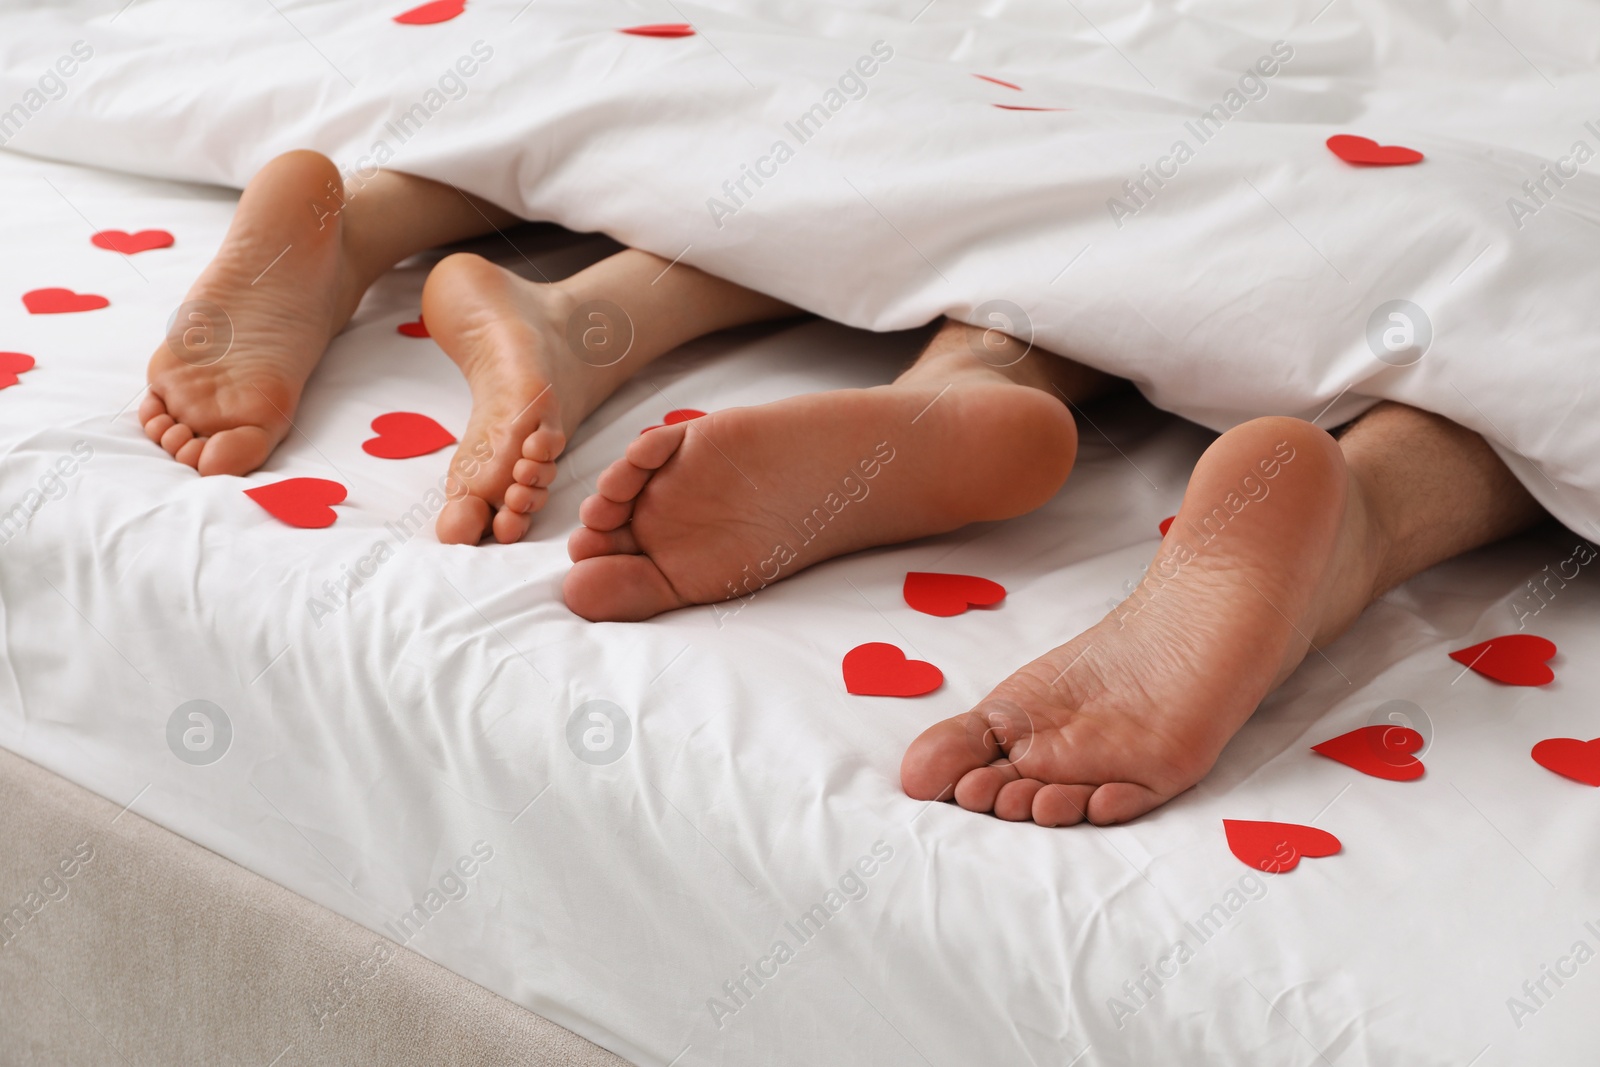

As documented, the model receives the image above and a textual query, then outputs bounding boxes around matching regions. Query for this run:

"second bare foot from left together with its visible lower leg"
[422,248,797,544]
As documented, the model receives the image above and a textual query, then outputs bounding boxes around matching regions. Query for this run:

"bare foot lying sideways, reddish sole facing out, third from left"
[562,376,1077,621]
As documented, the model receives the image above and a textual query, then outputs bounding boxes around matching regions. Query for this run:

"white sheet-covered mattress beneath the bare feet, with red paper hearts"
[0,143,1600,1067]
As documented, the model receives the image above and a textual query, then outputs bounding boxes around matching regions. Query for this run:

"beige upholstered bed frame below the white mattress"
[0,749,624,1067]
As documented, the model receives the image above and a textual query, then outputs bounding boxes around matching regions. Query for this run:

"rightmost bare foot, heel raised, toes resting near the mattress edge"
[901,418,1389,825]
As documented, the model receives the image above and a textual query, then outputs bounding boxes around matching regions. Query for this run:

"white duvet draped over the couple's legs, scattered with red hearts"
[0,0,1600,534]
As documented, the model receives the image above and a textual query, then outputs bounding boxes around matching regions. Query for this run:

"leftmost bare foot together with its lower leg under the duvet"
[139,152,512,475]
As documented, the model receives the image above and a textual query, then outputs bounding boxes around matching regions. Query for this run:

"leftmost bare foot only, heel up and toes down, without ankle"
[139,152,365,475]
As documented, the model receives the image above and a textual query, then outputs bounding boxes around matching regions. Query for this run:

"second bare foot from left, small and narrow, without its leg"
[422,253,597,544]
